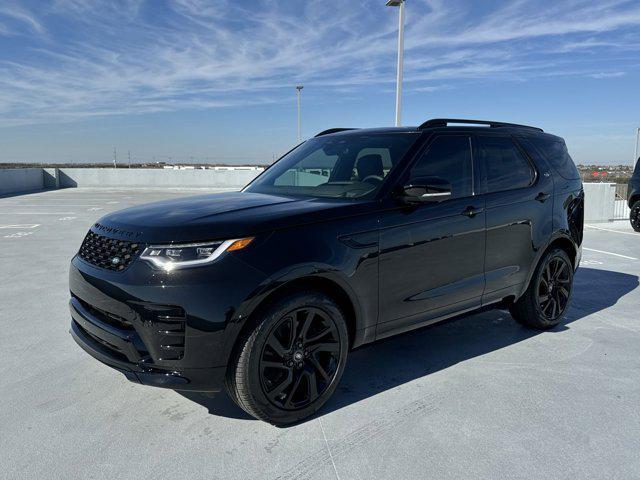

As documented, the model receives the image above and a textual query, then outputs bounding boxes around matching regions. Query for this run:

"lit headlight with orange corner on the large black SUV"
[140,237,254,271]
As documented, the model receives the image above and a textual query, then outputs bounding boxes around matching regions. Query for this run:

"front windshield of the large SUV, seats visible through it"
[245,132,419,198]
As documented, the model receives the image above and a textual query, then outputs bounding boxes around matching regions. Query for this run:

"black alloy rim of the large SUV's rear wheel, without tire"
[537,257,572,321]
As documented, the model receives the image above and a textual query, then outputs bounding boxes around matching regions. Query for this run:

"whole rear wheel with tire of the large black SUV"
[509,248,573,330]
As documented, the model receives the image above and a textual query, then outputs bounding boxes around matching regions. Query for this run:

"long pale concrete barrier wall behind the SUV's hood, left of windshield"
[58,168,260,188]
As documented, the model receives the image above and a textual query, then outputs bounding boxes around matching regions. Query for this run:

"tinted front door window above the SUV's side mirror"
[411,136,473,197]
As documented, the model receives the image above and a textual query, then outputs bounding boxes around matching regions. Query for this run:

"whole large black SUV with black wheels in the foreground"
[69,119,584,425]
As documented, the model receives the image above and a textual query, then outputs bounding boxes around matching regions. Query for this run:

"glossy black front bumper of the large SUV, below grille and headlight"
[69,253,268,392]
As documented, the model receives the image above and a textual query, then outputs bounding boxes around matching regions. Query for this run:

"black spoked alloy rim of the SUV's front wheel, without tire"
[260,307,340,410]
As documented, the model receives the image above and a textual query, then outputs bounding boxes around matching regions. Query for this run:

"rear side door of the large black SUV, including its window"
[474,134,553,303]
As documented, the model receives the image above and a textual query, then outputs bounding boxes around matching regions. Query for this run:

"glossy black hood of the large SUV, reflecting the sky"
[92,192,368,243]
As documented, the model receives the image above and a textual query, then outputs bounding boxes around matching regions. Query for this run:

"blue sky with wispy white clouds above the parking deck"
[0,0,640,164]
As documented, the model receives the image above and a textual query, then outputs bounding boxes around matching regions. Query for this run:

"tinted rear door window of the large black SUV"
[478,136,534,192]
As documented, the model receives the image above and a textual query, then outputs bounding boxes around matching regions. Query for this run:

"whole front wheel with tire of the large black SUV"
[226,291,349,425]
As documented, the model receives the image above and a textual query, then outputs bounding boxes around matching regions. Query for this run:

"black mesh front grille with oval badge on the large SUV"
[78,231,143,272]
